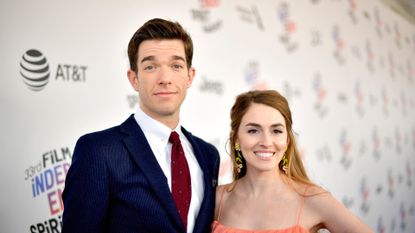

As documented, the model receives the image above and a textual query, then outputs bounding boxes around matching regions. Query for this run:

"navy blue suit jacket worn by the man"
[62,115,219,233]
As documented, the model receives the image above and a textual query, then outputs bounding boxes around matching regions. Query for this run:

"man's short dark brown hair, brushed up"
[128,18,193,72]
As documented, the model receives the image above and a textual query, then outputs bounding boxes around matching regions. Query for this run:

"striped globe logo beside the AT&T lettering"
[20,49,50,91]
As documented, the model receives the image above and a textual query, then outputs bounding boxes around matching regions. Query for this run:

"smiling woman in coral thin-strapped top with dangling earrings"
[212,90,373,233]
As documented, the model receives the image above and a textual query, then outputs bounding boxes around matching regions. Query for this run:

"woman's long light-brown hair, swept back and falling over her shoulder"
[229,90,313,185]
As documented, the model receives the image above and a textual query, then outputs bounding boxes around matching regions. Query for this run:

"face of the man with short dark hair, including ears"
[128,40,195,124]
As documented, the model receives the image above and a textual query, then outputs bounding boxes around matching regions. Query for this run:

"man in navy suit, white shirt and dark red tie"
[62,19,219,233]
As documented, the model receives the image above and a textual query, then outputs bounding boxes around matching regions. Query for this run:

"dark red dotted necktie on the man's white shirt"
[169,131,192,228]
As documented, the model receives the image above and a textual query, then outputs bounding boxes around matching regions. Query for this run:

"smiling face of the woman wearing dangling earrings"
[236,103,288,172]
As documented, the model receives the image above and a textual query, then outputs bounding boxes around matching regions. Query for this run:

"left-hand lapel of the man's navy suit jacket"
[121,115,183,231]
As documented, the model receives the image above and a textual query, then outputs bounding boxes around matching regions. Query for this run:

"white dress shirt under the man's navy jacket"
[134,108,204,232]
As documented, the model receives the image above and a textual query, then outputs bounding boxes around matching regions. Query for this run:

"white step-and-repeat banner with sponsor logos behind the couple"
[0,0,415,233]
